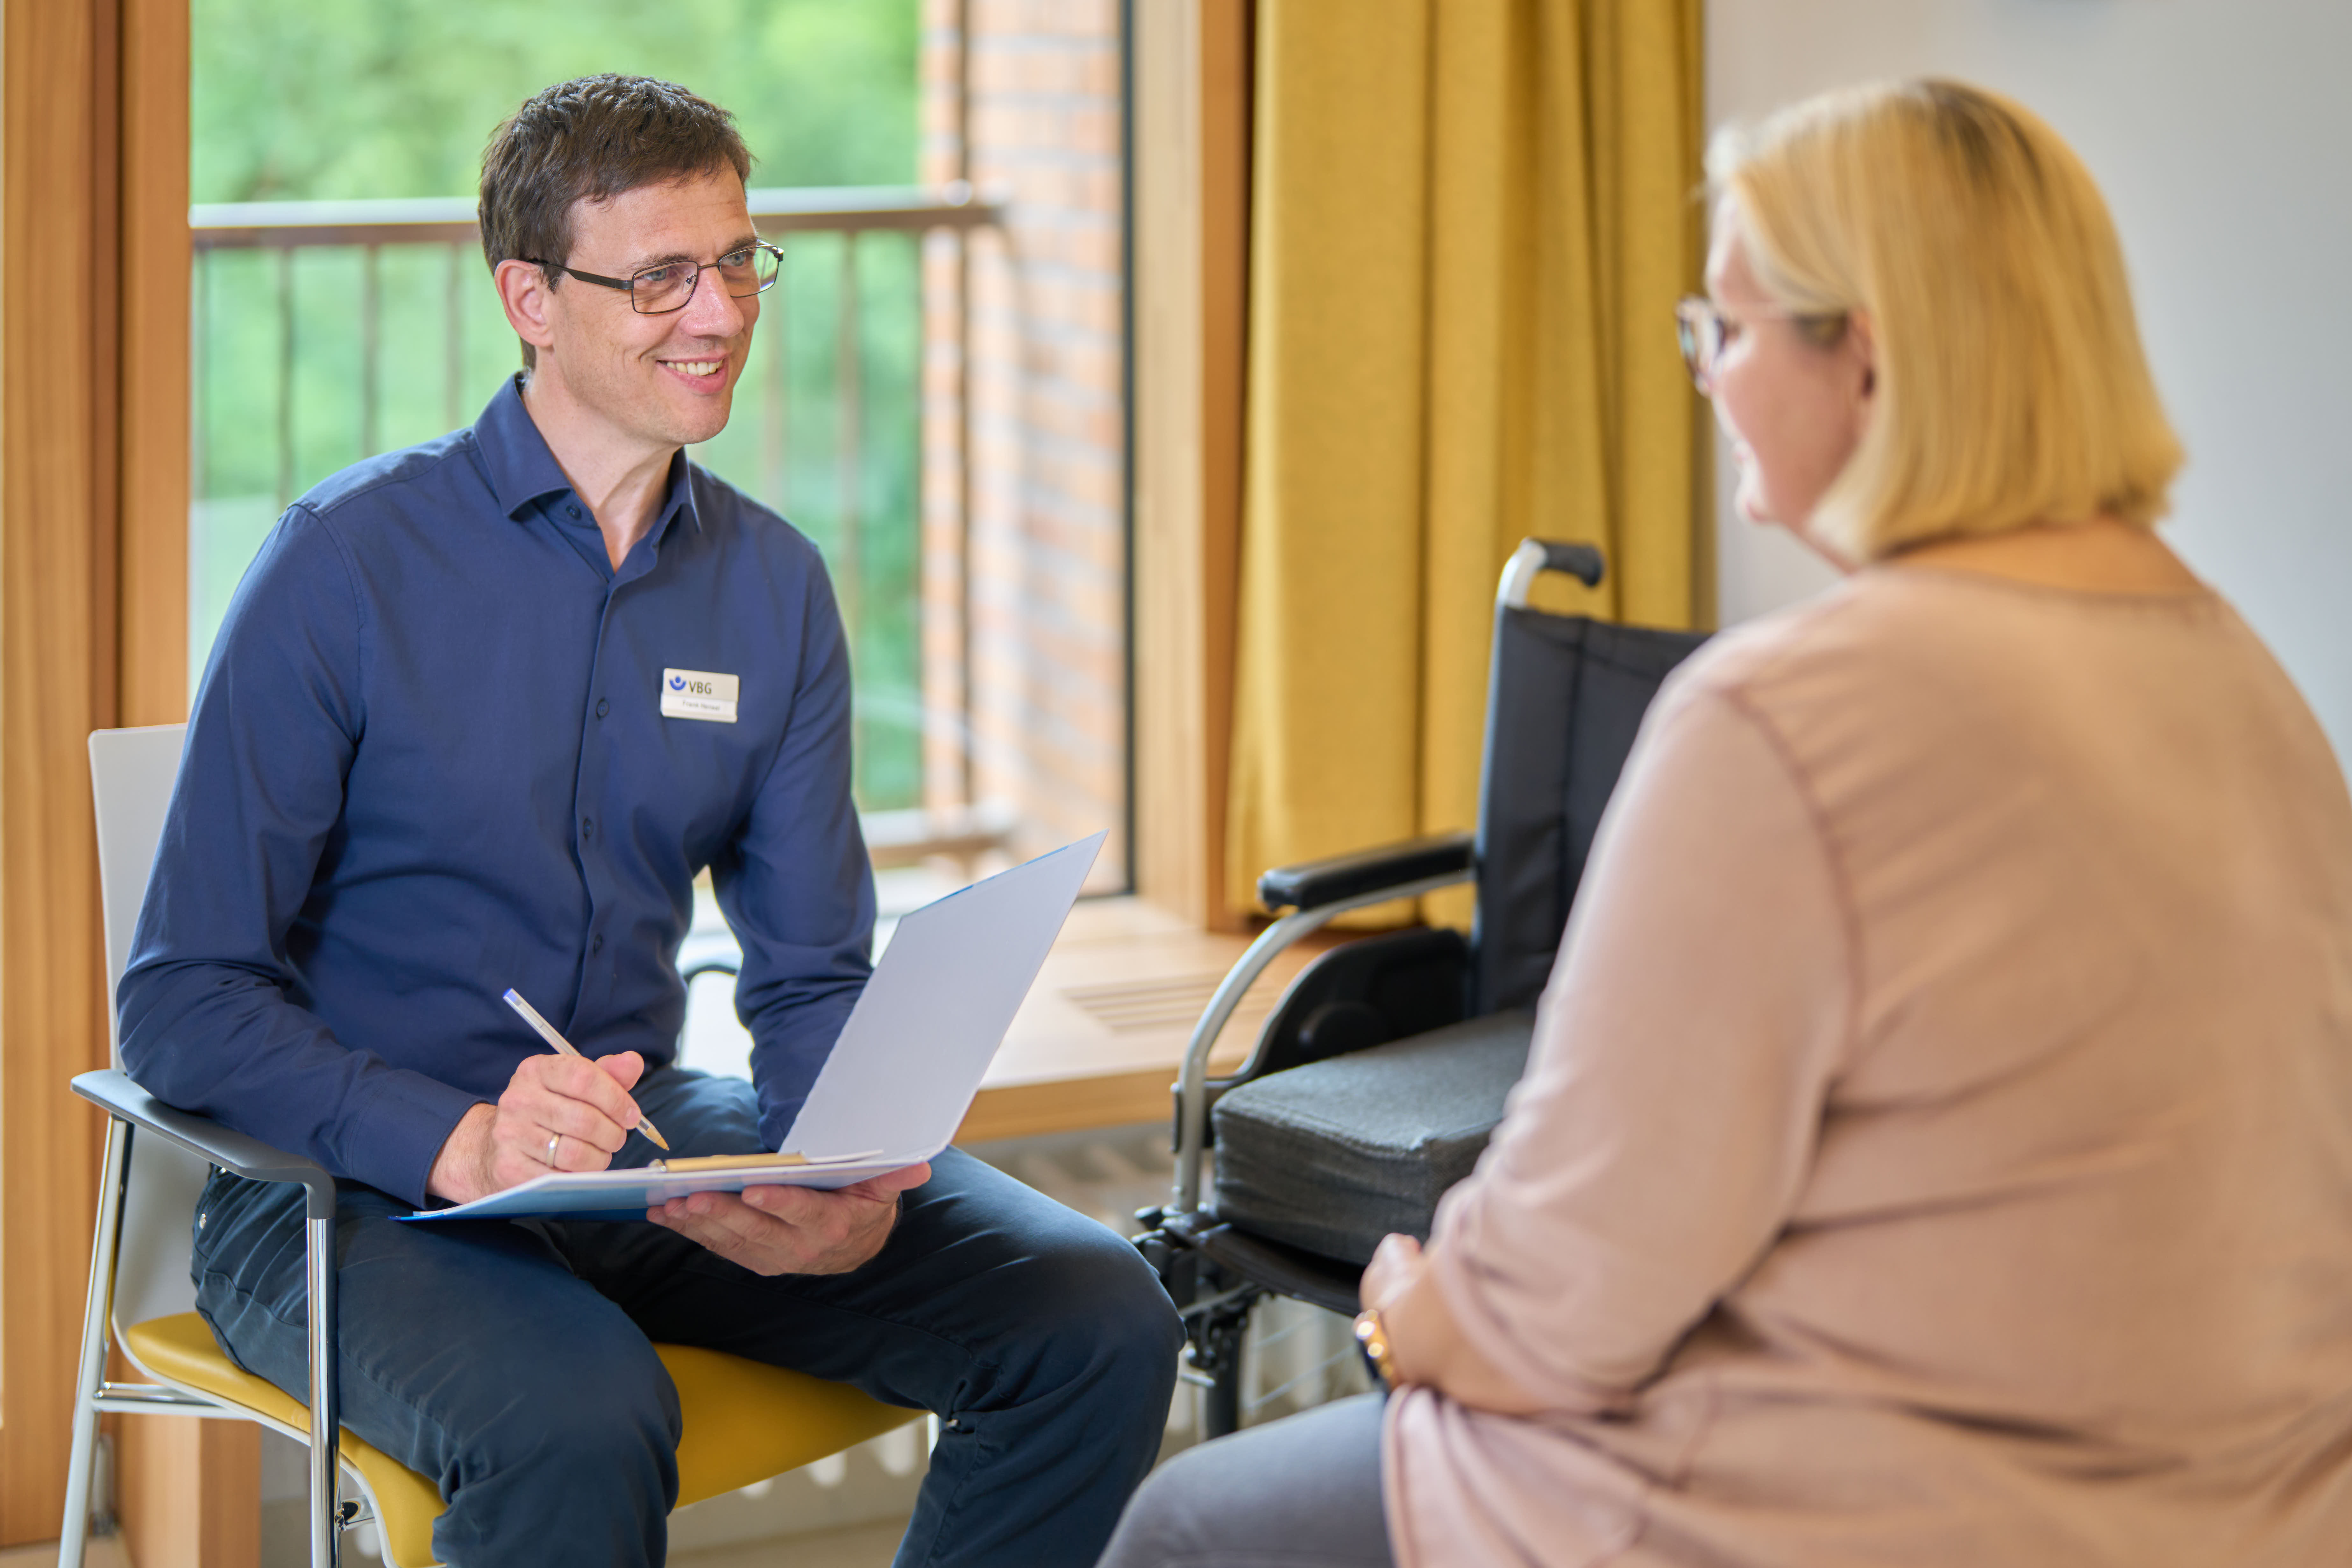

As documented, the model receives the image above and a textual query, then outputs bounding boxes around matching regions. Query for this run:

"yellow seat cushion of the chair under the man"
[122,1312,922,1568]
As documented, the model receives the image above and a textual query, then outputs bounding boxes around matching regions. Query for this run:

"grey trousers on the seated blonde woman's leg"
[1098,1394,1395,1568]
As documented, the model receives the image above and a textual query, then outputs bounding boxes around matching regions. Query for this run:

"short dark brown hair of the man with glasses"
[478,75,750,367]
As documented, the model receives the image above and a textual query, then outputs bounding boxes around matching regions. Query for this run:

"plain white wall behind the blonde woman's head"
[1708,0,2352,757]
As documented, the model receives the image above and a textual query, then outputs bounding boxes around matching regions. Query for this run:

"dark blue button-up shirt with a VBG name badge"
[117,383,873,1204]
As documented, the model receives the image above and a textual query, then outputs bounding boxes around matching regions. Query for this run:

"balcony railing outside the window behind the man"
[188,186,1002,832]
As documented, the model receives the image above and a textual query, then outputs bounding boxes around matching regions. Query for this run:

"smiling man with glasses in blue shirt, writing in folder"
[120,78,1181,1568]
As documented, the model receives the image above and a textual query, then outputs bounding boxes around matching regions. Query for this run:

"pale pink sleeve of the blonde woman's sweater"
[1430,670,1856,1413]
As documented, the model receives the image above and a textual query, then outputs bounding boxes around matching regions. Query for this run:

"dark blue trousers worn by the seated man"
[195,1067,1183,1568]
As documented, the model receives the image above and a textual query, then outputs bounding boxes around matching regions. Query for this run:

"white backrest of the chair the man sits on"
[89,724,209,1335]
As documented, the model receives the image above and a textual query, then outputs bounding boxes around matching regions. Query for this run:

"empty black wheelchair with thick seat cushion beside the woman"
[1136,538,1705,1437]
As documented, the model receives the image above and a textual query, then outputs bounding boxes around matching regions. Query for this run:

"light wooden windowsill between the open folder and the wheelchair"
[957,896,1348,1143]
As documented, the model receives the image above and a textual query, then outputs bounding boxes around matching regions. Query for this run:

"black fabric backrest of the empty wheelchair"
[1470,604,1705,1016]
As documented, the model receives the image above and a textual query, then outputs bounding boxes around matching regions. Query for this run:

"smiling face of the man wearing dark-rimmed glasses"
[534,169,760,447]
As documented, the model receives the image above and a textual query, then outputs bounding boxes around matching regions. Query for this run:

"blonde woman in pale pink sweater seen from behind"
[1105,80,2352,1568]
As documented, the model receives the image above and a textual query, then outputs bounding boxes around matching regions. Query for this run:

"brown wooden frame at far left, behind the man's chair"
[0,0,214,1566]
